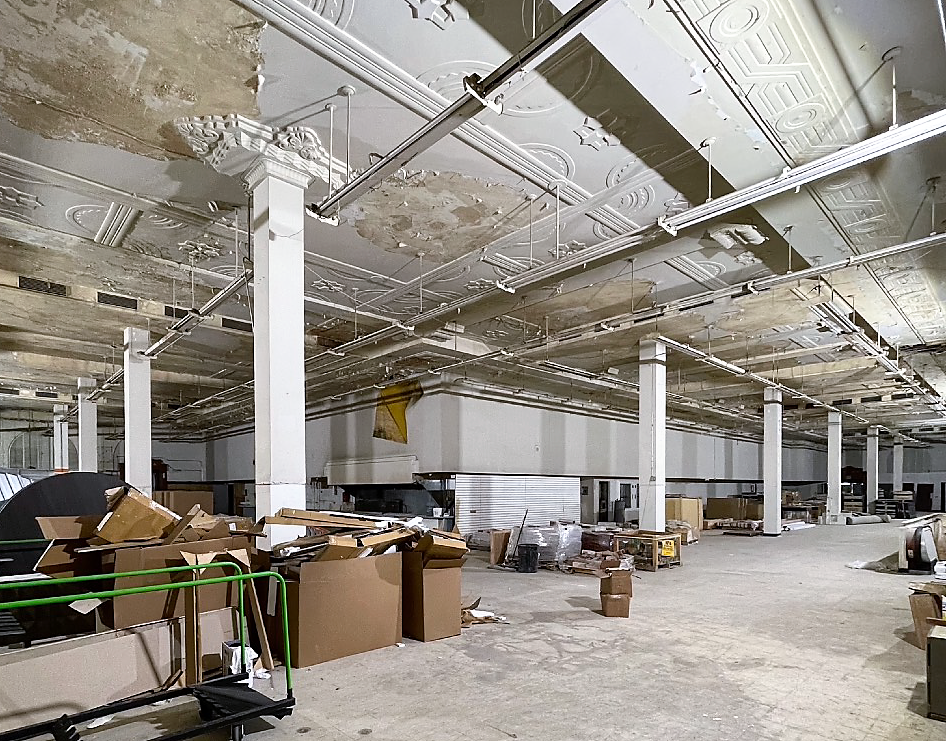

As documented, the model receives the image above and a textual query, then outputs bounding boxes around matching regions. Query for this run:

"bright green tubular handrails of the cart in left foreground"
[0,561,292,697]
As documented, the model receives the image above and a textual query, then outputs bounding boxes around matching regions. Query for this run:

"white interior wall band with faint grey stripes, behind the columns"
[201,389,827,496]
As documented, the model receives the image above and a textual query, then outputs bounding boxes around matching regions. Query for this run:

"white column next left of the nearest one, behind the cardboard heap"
[124,327,151,496]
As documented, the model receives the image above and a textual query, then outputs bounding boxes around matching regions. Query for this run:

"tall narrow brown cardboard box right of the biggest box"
[401,551,463,641]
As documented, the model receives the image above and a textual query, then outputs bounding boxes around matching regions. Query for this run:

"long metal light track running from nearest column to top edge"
[306,0,610,218]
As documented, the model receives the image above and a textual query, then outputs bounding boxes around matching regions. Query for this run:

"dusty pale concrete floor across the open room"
[96,525,932,741]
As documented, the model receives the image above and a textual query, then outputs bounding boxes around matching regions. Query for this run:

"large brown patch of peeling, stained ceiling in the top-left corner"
[0,0,262,159]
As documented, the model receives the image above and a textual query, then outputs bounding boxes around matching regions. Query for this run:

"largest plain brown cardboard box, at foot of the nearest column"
[278,553,402,668]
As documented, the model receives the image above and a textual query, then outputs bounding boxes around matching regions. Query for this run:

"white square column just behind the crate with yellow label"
[637,340,667,533]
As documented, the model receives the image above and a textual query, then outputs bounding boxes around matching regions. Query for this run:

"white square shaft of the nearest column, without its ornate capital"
[245,158,312,543]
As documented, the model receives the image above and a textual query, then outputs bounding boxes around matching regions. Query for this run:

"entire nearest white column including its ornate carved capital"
[176,114,340,547]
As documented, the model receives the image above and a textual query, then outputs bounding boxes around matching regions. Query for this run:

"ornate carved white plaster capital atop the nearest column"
[174,113,344,190]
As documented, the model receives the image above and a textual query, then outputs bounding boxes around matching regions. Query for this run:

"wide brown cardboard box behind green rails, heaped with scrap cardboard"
[100,537,252,628]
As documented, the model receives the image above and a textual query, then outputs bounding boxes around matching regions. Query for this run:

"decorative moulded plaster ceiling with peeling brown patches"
[0,0,946,442]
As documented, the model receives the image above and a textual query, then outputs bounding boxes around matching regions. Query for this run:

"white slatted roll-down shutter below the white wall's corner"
[455,473,581,535]
